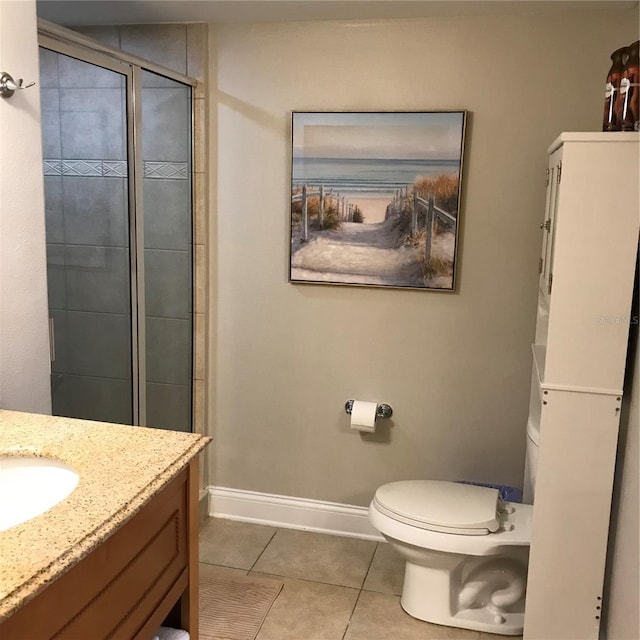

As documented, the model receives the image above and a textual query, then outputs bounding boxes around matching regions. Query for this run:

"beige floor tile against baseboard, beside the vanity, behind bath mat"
[200,518,277,569]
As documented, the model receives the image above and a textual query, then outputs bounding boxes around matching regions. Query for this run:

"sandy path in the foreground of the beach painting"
[291,219,424,287]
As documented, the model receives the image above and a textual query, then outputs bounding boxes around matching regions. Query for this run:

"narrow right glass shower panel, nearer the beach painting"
[141,70,193,431]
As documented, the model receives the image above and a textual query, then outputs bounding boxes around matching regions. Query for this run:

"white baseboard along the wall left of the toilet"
[208,486,384,541]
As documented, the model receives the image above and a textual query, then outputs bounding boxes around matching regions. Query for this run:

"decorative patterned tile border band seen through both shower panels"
[43,158,189,180]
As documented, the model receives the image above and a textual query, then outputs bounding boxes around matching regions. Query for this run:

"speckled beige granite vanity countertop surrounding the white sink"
[0,410,211,621]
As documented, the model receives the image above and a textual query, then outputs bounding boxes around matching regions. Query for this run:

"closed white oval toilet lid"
[373,480,500,535]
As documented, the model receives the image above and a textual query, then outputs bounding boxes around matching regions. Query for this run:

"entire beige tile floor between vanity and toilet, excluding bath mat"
[200,518,515,640]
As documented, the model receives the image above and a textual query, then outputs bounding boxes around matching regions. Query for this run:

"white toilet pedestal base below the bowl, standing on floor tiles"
[400,556,526,636]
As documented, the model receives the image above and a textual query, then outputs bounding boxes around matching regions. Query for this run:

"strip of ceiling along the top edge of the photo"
[37,0,638,26]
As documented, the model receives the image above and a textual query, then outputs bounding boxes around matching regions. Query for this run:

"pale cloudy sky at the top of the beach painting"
[293,111,463,160]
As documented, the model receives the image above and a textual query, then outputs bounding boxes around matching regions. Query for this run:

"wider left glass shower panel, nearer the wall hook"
[40,48,136,424]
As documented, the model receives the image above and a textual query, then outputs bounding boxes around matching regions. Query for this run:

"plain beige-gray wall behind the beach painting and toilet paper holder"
[209,8,638,505]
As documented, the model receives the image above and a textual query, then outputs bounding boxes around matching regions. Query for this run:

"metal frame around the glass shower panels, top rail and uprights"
[38,18,197,430]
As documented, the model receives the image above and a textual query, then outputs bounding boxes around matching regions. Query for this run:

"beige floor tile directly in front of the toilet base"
[344,591,480,640]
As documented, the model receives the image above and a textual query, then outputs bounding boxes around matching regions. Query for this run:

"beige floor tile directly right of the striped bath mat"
[249,572,359,640]
